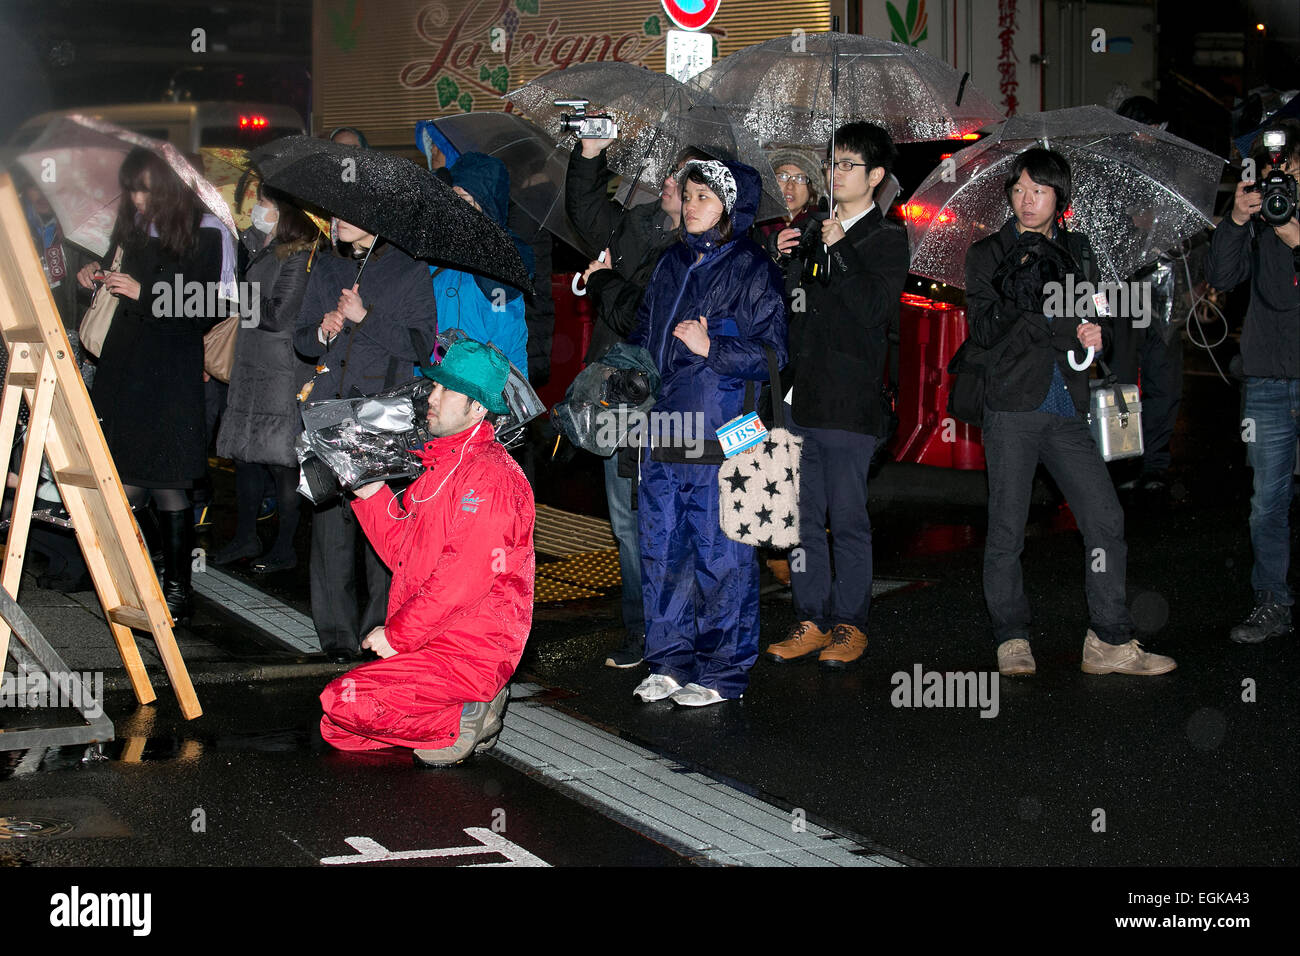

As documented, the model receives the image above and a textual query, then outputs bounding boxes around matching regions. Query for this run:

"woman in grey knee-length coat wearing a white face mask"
[212,176,320,574]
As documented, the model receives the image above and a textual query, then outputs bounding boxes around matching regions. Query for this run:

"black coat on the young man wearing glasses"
[783,207,911,436]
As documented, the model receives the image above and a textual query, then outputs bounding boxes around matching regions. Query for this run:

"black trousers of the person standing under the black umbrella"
[311,499,393,653]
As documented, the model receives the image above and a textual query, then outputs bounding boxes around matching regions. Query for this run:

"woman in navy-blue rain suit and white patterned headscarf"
[628,161,787,706]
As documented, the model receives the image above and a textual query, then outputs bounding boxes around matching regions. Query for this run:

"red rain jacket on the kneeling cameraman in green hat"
[352,423,536,700]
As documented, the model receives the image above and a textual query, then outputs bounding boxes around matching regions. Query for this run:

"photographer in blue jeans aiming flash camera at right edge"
[1206,121,1300,644]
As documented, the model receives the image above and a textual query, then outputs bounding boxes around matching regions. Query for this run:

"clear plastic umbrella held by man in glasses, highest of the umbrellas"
[692,33,1002,148]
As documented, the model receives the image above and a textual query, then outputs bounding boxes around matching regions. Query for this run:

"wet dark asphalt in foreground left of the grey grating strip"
[0,680,686,866]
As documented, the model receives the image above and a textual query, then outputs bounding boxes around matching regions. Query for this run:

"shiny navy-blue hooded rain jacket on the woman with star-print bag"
[628,163,788,457]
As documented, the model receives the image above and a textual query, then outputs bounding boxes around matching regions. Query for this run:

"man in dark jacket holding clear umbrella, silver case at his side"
[966,148,1177,676]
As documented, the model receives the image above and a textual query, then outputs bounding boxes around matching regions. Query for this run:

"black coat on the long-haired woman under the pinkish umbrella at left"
[91,219,222,488]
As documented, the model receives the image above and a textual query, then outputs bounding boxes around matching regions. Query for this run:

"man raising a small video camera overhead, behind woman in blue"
[564,121,711,667]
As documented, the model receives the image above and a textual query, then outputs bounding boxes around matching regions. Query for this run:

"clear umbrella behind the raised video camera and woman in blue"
[506,61,785,220]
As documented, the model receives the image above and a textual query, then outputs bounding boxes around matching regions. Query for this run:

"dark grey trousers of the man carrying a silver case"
[984,408,1134,644]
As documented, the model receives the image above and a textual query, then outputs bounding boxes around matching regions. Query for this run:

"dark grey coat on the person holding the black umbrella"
[294,243,438,402]
